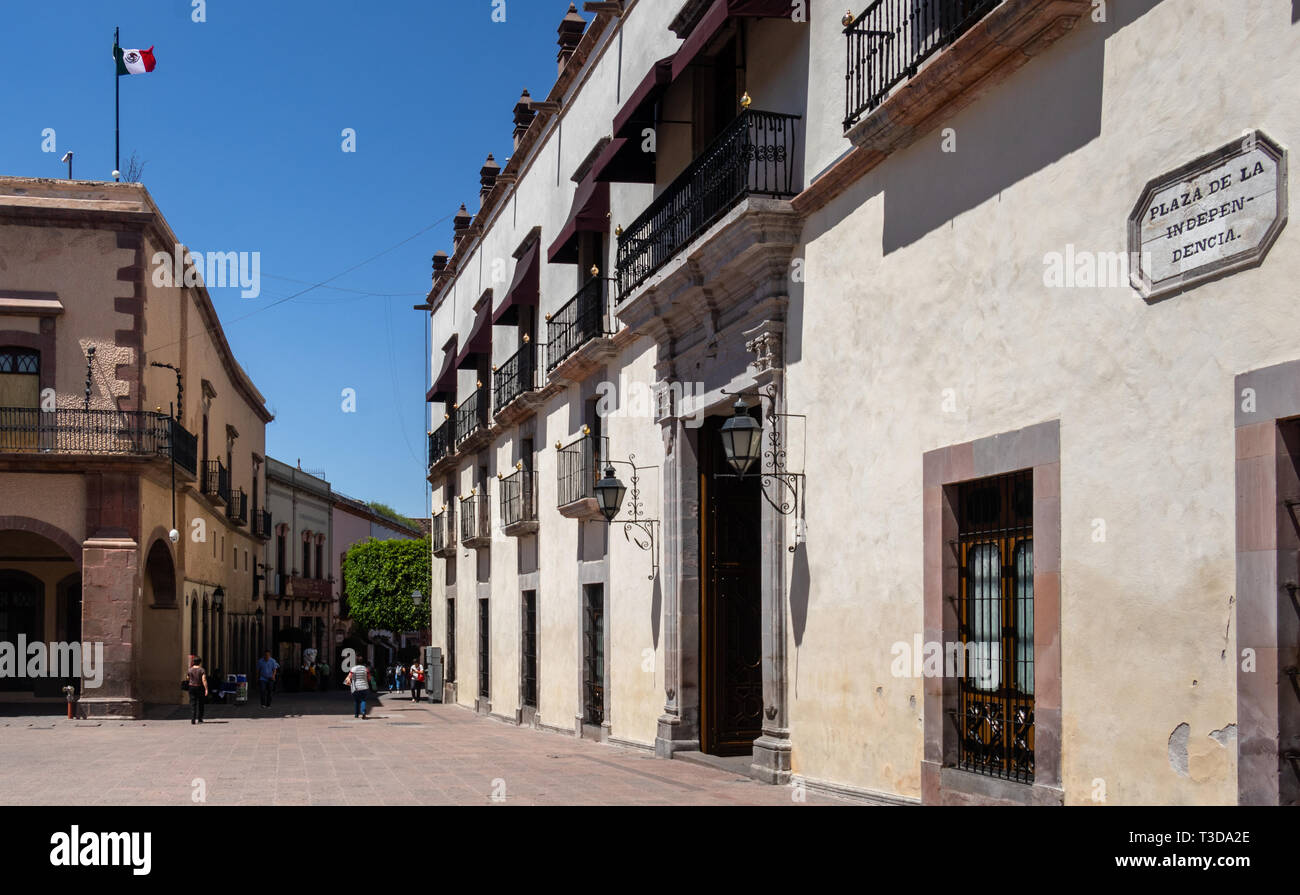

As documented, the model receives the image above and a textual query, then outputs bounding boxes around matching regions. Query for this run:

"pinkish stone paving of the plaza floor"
[0,693,841,805]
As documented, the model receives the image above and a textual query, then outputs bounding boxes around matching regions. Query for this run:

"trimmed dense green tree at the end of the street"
[343,537,433,634]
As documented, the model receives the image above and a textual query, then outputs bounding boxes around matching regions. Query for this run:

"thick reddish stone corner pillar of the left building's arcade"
[79,537,143,718]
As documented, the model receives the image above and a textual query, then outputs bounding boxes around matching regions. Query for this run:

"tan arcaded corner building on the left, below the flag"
[0,177,272,717]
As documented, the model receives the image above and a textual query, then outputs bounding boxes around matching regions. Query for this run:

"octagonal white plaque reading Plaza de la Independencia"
[1128,130,1287,302]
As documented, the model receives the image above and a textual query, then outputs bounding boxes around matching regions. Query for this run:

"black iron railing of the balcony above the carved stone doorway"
[618,109,800,302]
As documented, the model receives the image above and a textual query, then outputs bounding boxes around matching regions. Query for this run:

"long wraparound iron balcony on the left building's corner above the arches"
[0,407,198,476]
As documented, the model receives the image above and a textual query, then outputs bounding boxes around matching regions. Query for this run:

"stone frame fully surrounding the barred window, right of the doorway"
[920,420,1065,805]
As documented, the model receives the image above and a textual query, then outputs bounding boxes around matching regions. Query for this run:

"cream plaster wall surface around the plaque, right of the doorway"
[789,0,1300,804]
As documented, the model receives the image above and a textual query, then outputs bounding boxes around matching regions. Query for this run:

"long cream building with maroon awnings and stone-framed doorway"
[428,0,1300,804]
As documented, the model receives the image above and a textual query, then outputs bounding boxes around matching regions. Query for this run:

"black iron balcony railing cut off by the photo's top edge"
[844,0,1002,130]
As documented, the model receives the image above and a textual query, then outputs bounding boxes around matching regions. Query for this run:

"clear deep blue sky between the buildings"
[0,0,569,516]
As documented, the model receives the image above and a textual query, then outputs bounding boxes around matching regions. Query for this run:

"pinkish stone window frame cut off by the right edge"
[1232,360,1300,805]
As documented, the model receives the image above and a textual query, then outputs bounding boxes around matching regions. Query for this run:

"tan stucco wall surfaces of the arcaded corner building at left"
[0,178,265,702]
